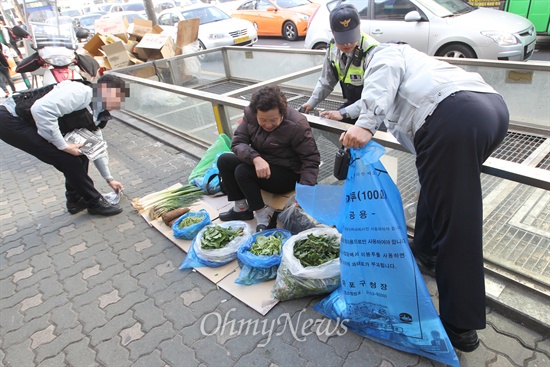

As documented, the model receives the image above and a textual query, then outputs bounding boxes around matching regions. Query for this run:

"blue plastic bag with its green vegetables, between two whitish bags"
[235,228,292,285]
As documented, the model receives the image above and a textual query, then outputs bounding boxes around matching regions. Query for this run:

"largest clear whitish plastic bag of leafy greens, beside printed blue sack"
[271,227,342,301]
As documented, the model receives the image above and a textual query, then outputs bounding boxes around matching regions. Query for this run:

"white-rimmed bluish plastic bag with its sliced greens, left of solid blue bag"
[180,220,252,269]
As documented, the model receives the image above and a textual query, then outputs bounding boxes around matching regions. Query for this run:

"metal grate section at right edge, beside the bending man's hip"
[491,132,546,163]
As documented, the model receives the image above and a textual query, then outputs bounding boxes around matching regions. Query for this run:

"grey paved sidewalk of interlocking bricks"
[0,110,550,367]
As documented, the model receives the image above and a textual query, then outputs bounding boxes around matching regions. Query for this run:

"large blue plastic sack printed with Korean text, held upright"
[296,141,459,366]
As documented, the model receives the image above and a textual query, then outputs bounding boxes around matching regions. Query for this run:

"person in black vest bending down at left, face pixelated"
[0,74,129,216]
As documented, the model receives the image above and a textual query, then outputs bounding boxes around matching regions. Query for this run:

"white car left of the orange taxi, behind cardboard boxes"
[158,4,258,50]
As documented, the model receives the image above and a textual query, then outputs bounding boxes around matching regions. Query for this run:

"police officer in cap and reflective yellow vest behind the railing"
[302,4,378,124]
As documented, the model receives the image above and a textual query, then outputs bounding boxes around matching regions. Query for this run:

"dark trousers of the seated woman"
[218,153,300,210]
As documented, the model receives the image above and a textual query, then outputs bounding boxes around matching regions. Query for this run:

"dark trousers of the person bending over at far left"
[0,106,101,205]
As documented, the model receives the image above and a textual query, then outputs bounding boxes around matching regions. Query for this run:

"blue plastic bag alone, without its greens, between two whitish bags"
[235,228,292,285]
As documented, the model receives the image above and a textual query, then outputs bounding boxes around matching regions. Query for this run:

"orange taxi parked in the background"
[231,0,319,41]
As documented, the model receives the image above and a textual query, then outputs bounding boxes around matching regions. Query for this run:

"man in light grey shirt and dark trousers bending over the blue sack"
[340,3,509,352]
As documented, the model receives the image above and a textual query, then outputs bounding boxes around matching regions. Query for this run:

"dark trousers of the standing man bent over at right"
[414,92,509,329]
